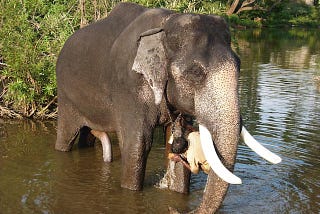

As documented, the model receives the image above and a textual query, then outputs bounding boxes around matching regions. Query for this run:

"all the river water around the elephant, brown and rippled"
[0,29,320,214]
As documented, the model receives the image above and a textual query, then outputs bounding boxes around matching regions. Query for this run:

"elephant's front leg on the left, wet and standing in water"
[119,129,152,190]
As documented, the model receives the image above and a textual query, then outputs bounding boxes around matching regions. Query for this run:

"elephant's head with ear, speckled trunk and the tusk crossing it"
[132,14,278,213]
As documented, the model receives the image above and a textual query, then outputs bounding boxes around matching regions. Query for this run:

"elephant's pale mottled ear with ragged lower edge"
[132,28,168,105]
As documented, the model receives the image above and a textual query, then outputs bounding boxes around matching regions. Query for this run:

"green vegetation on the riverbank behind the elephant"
[0,0,320,118]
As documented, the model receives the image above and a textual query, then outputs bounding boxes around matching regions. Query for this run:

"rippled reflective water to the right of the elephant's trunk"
[222,27,320,213]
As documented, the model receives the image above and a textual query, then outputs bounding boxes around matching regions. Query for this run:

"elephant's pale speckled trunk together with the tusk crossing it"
[195,57,241,213]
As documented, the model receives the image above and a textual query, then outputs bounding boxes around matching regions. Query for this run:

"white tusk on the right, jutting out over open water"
[241,126,281,164]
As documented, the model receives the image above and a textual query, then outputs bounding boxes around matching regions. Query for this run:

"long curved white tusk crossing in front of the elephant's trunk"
[199,124,242,184]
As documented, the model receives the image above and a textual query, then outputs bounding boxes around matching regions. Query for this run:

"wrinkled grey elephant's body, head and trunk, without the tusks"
[55,3,240,213]
